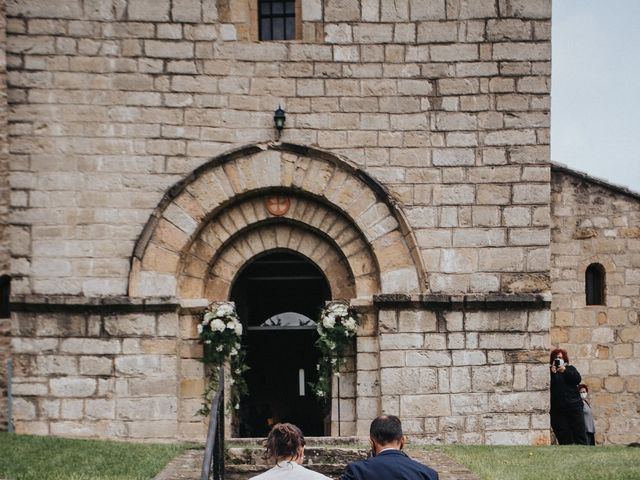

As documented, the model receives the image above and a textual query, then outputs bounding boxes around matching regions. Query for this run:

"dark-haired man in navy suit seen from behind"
[341,415,438,480]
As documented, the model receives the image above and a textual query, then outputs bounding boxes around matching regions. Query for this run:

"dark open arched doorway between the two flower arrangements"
[231,249,331,437]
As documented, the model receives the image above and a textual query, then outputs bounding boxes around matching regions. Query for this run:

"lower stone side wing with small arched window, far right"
[551,166,640,444]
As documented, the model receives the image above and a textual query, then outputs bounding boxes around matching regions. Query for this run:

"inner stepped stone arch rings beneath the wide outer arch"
[178,192,378,298]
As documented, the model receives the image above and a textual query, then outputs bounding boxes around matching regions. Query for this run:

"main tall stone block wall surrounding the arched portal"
[7,0,551,443]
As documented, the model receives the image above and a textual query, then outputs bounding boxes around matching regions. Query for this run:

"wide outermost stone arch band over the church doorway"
[129,144,426,297]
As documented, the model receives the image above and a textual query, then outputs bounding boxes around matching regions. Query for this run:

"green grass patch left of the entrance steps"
[0,433,193,480]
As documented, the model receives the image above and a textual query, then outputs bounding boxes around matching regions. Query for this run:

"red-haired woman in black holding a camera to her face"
[549,348,587,445]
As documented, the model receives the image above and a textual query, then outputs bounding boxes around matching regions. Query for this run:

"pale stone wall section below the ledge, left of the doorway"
[12,300,185,441]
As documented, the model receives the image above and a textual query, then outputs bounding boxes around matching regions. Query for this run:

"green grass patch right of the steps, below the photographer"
[425,445,640,480]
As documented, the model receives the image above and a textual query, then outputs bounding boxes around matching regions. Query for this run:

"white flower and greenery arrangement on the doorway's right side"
[312,300,359,400]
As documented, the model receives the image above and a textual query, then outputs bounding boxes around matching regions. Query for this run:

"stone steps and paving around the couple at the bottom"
[154,437,479,480]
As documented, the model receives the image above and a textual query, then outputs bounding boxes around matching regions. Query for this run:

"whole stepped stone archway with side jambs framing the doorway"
[129,144,427,435]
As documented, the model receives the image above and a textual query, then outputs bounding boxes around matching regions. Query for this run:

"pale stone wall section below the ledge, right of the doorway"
[379,300,550,445]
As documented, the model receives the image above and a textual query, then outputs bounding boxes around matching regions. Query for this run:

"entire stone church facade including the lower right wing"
[0,0,640,444]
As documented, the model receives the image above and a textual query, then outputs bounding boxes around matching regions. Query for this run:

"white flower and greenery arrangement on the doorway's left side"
[198,302,248,416]
